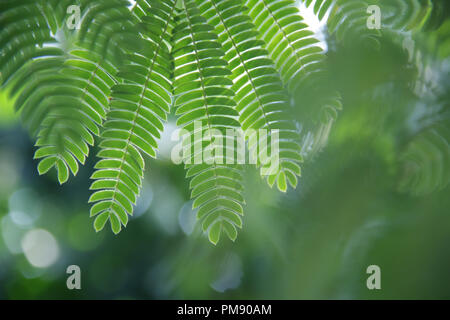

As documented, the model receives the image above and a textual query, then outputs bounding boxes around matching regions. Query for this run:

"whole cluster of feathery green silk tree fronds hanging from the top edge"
[0,0,445,244]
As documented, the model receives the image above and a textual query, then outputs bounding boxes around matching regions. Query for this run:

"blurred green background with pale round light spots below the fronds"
[0,1,450,299]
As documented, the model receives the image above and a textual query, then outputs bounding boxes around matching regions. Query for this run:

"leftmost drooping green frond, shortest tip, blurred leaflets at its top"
[5,0,139,183]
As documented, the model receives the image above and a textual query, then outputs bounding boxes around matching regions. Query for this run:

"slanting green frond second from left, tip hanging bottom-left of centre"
[89,1,175,233]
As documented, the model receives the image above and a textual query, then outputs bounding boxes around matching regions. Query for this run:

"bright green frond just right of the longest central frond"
[198,0,302,191]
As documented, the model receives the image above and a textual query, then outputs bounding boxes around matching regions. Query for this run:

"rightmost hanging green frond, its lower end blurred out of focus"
[246,0,341,156]
